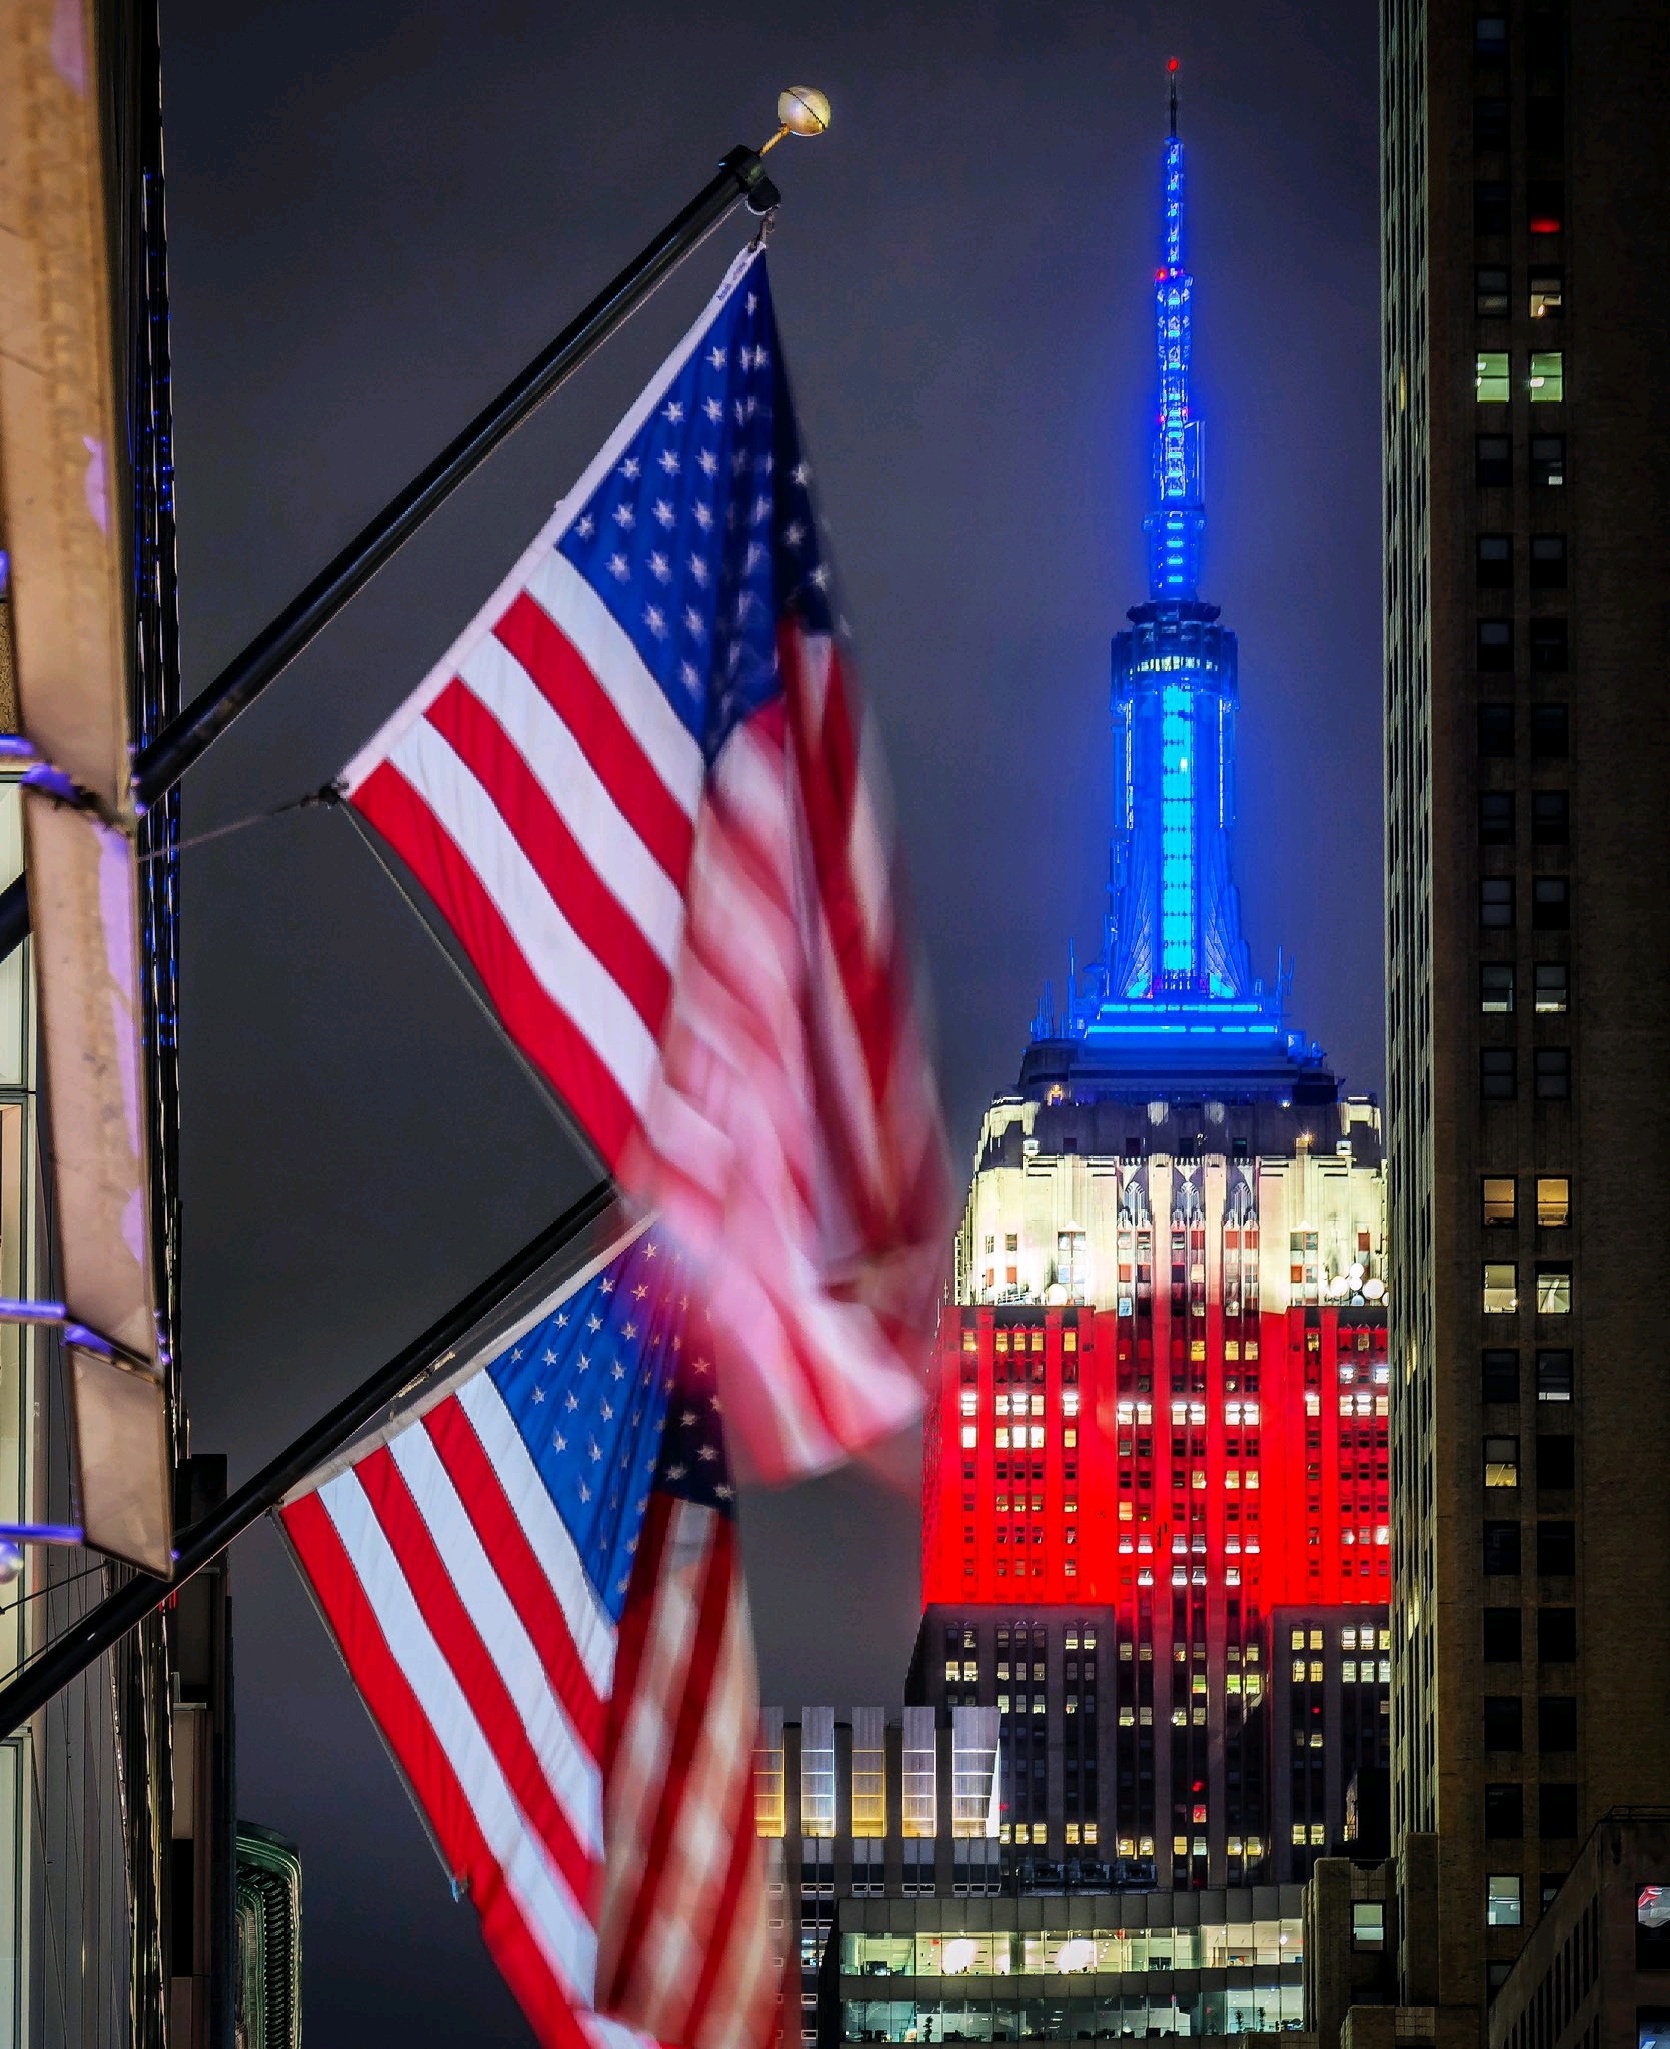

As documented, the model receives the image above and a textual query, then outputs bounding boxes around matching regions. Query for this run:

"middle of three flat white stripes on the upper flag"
[459,635,684,967]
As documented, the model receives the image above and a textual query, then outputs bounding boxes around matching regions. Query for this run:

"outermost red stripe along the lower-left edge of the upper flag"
[350,762,637,1172]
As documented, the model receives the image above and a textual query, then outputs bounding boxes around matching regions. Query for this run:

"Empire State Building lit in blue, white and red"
[910,84,1391,1887]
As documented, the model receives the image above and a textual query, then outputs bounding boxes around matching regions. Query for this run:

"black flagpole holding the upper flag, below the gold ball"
[0,143,781,961]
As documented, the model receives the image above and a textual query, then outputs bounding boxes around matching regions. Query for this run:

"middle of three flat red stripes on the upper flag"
[424,676,672,1037]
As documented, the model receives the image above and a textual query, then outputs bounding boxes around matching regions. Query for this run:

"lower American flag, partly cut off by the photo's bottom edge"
[279,1229,781,2049]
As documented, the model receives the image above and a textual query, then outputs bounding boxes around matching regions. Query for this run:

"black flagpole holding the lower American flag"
[0,1180,615,1740]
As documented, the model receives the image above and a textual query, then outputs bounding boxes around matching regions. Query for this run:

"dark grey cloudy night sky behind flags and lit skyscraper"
[162,0,1381,2049]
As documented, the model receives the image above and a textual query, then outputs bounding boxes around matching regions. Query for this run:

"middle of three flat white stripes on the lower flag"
[389,1430,602,1856]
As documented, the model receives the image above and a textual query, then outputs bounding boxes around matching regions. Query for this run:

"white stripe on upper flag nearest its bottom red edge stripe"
[389,719,660,1109]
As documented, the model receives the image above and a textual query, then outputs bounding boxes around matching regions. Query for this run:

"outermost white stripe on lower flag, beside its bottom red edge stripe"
[320,1473,596,2004]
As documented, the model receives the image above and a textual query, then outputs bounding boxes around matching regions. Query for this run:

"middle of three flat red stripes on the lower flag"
[354,1447,594,1901]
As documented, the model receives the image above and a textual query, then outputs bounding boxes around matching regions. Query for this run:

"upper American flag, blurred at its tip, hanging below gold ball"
[342,250,949,1477]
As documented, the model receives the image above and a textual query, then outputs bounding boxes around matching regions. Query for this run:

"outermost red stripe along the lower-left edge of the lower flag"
[281,1494,594,2049]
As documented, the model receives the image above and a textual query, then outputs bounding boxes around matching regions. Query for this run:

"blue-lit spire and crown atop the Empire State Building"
[1022,75,1334,1100]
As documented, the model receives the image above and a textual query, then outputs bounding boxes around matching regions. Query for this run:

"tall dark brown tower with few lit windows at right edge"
[1381,0,1670,2041]
